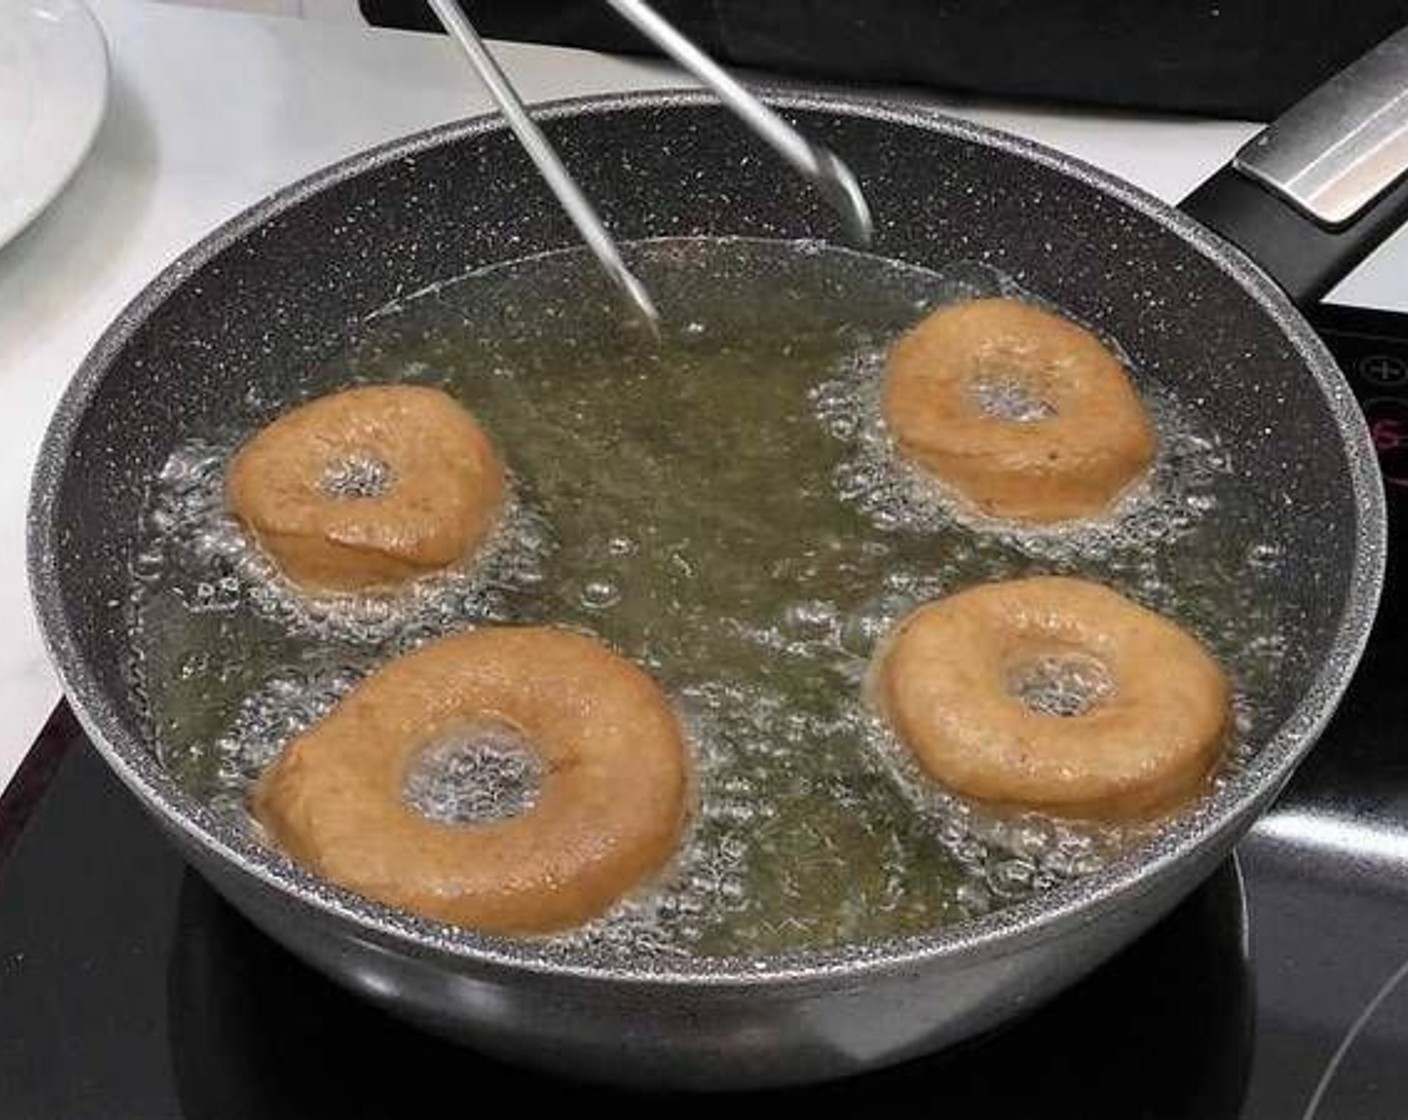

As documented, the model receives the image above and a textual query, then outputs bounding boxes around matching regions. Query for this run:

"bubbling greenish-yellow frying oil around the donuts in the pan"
[131,239,1287,955]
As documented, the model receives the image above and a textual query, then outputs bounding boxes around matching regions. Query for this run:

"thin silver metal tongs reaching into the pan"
[429,0,872,331]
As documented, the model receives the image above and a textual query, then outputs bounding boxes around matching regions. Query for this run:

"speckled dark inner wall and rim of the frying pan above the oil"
[41,94,1380,975]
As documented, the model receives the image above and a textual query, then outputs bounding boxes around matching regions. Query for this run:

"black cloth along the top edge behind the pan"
[360,0,1408,120]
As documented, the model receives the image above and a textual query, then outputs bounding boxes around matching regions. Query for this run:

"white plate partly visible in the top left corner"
[0,0,107,245]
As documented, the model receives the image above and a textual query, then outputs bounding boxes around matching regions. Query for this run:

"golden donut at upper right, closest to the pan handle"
[883,299,1155,523]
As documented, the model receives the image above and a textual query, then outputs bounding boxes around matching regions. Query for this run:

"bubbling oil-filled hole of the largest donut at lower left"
[401,720,546,824]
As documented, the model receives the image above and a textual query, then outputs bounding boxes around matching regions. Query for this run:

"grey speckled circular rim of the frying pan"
[27,89,1387,989]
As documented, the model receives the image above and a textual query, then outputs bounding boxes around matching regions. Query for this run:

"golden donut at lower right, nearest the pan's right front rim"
[872,576,1231,820]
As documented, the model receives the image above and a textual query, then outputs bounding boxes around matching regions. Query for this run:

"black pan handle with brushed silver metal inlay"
[1180,28,1408,307]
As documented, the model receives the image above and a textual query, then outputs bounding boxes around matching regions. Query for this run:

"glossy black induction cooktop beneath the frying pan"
[0,309,1408,1120]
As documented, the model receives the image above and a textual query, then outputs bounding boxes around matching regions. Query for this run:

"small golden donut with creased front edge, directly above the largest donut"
[225,385,504,592]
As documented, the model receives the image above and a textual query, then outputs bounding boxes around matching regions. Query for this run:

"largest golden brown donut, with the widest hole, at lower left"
[253,627,690,934]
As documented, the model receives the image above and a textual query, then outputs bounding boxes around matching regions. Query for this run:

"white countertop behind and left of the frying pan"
[0,0,1408,788]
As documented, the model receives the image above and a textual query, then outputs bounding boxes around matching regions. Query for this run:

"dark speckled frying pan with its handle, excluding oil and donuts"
[30,28,1408,1088]
